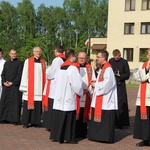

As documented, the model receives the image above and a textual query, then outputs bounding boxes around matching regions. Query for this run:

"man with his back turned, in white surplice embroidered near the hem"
[50,50,83,144]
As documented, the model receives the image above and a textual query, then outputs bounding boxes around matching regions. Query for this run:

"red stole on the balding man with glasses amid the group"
[74,62,92,122]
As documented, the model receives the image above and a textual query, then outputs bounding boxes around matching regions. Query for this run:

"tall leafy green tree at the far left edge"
[0,1,19,59]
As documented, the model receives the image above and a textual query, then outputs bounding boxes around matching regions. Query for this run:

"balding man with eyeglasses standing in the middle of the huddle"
[75,51,96,138]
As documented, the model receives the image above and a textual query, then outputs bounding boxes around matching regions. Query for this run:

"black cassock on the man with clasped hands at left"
[0,58,23,123]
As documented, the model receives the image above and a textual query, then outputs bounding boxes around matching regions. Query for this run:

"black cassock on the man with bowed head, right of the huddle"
[109,58,130,127]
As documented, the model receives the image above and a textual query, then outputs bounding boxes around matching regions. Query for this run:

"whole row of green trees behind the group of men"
[0,0,108,64]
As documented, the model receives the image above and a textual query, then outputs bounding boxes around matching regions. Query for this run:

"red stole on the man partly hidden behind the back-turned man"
[42,53,65,111]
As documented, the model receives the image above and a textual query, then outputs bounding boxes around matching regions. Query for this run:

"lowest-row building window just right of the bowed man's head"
[123,48,133,61]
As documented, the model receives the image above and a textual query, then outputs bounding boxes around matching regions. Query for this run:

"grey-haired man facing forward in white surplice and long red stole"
[20,47,46,128]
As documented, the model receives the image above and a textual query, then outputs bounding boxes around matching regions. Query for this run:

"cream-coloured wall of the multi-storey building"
[107,0,150,69]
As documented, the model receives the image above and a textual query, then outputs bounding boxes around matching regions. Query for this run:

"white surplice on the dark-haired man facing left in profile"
[91,67,118,110]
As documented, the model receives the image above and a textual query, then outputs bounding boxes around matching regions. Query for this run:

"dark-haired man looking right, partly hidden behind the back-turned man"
[43,45,66,131]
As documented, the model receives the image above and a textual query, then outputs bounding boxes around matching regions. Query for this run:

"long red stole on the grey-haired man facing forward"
[28,56,46,110]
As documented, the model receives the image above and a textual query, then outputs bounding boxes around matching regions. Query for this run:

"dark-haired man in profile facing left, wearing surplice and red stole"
[87,50,118,143]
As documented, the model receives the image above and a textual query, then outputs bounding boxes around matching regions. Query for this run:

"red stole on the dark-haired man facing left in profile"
[89,62,111,122]
